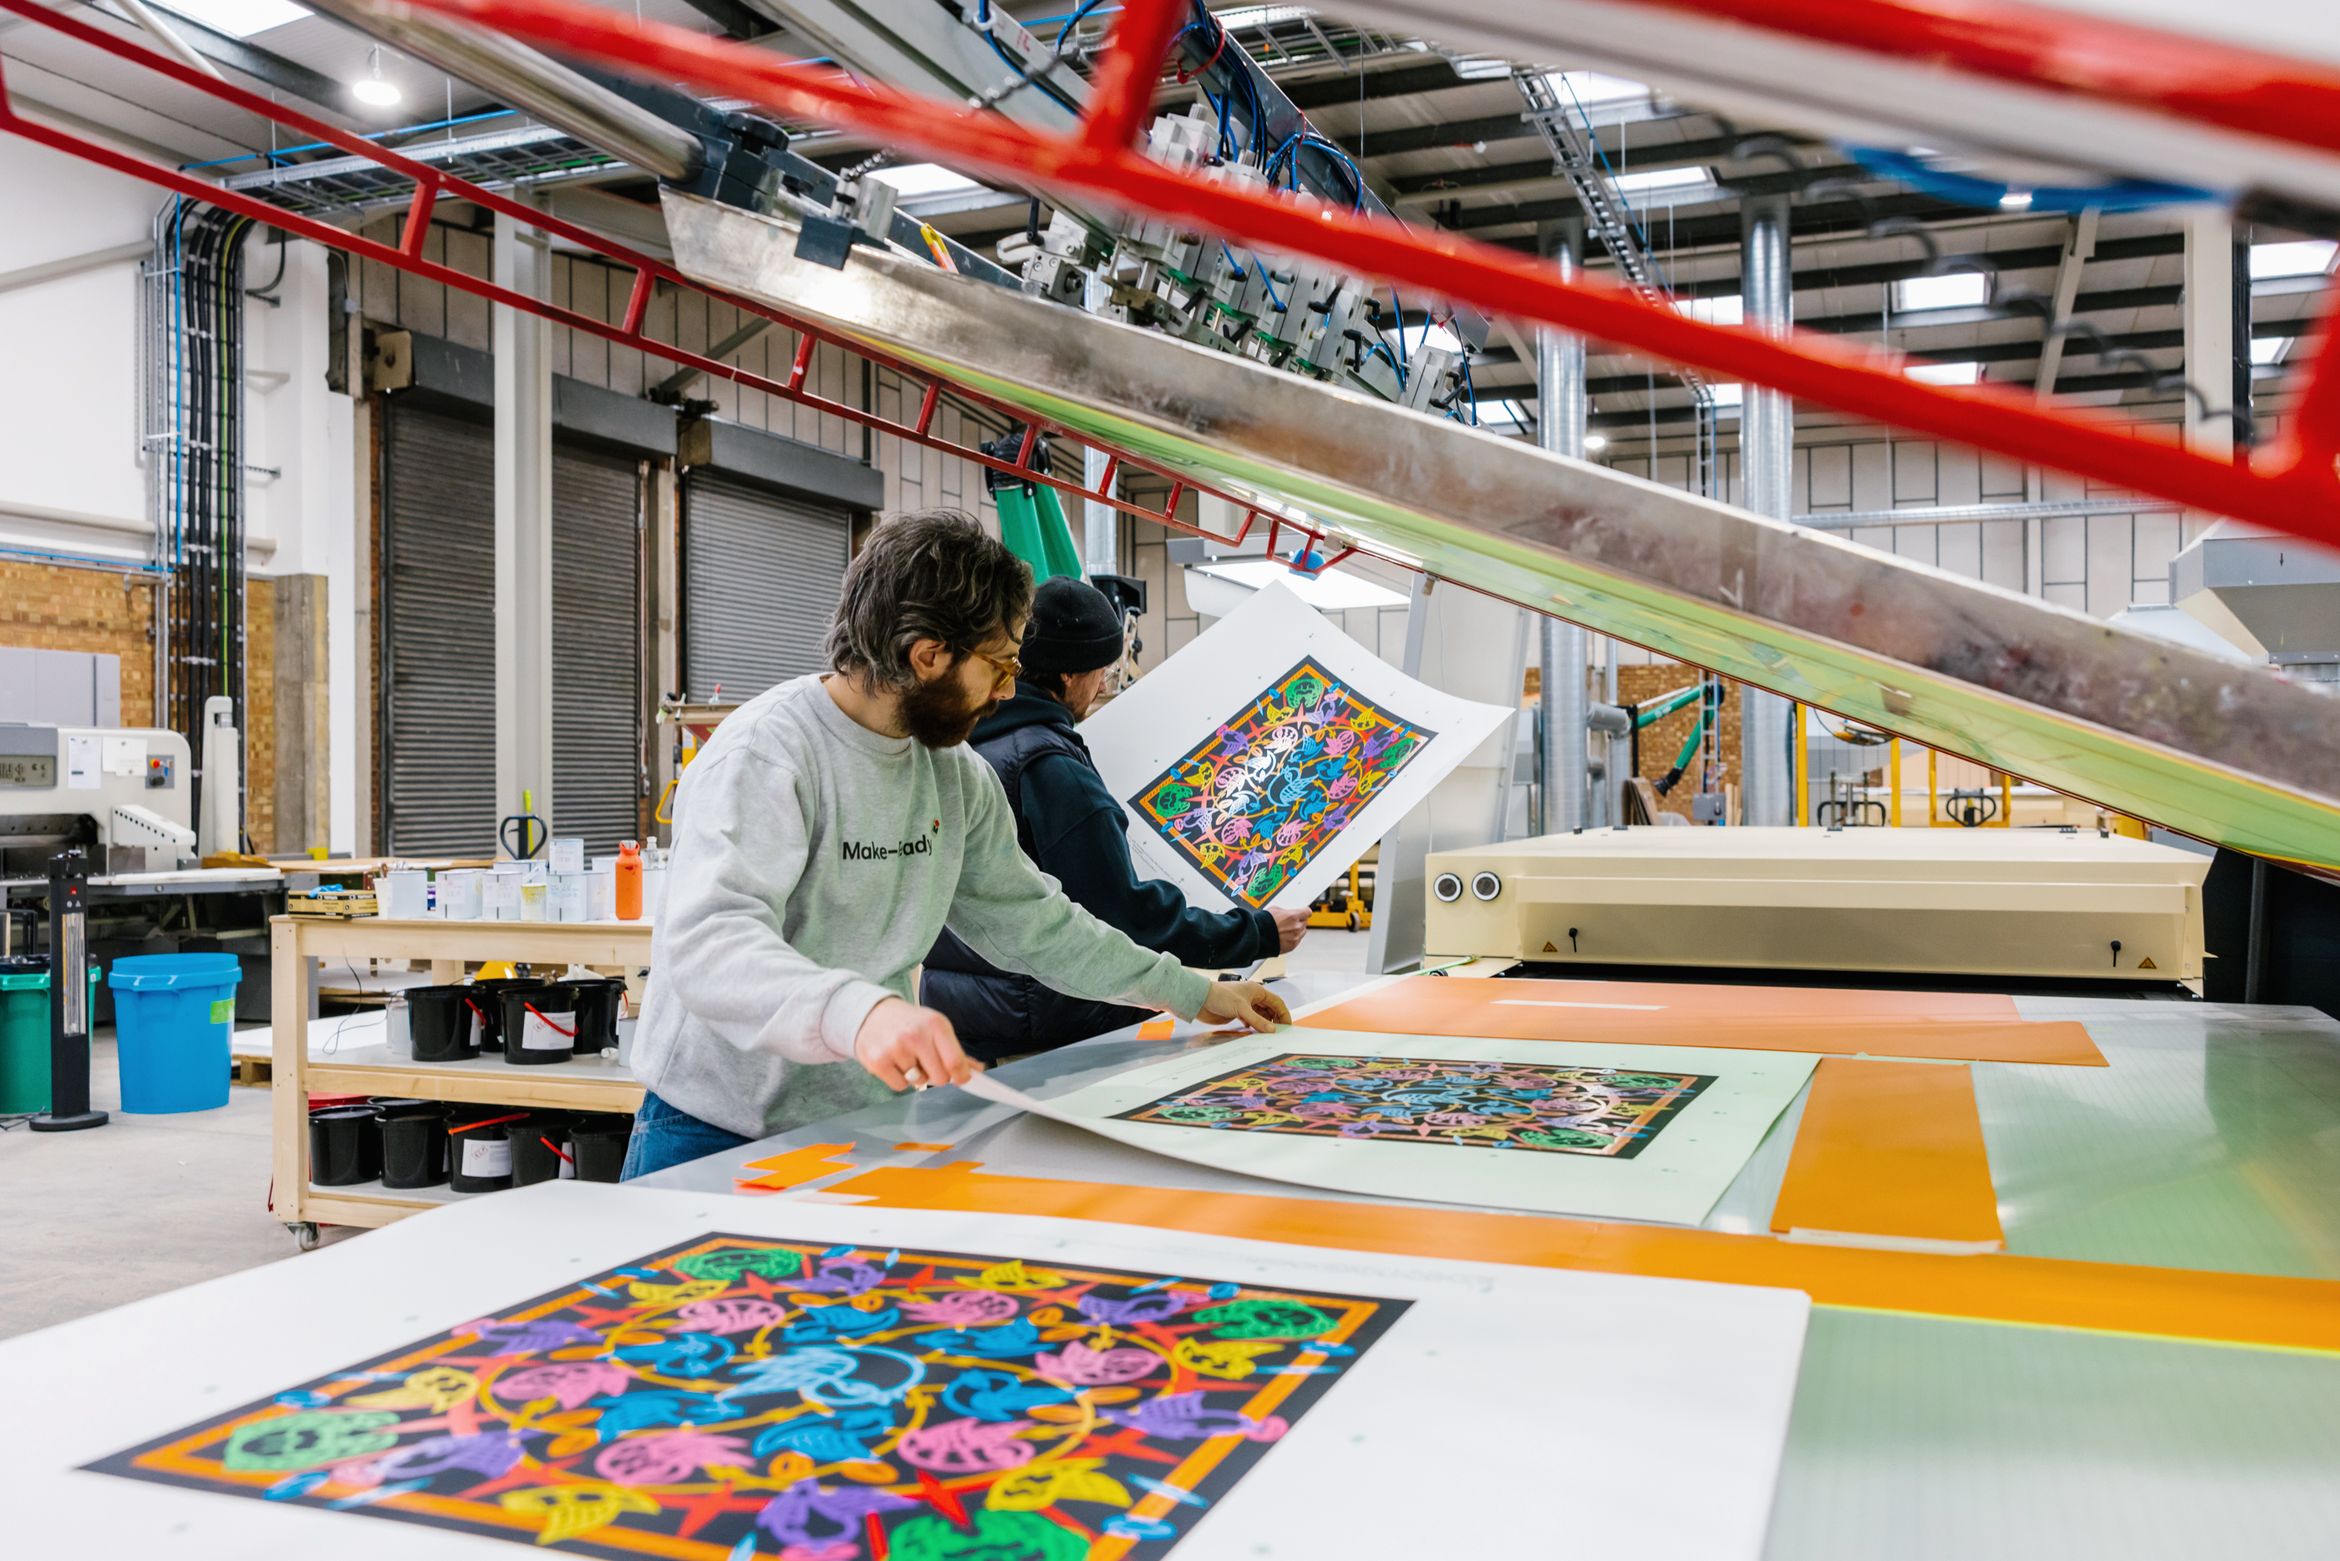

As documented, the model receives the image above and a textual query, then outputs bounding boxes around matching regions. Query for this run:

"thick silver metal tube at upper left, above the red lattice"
[314,0,707,183]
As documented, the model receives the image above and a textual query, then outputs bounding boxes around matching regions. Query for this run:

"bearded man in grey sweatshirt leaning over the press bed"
[625,510,1292,1180]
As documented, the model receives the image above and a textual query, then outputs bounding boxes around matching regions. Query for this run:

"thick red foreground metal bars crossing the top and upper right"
[369,0,2340,545]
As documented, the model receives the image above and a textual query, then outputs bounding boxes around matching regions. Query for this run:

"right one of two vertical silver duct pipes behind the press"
[1739,197,1795,824]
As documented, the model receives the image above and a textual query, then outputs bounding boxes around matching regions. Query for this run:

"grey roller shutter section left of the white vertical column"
[381,400,498,857]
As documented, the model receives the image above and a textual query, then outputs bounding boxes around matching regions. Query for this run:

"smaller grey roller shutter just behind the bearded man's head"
[683,470,852,702]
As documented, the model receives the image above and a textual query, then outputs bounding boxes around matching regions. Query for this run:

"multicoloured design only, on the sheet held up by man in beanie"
[1130,660,1437,906]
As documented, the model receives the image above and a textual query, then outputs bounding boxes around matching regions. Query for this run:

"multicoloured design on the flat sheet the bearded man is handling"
[1114,1051,1713,1161]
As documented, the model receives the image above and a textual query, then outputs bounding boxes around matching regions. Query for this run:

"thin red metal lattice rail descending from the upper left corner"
[0,0,1355,568]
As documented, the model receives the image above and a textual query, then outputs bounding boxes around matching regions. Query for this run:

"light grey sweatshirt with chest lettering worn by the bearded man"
[634,676,1210,1137]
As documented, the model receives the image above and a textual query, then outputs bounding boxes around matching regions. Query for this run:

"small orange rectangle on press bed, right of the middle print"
[1771,1058,2003,1245]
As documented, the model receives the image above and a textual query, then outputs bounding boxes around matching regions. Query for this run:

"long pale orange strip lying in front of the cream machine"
[1301,976,2104,1067]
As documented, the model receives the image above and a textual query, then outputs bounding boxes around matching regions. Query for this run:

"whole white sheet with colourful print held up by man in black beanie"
[1081,585,1512,906]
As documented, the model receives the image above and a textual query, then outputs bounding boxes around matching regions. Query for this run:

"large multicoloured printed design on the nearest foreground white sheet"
[91,1236,1409,1561]
